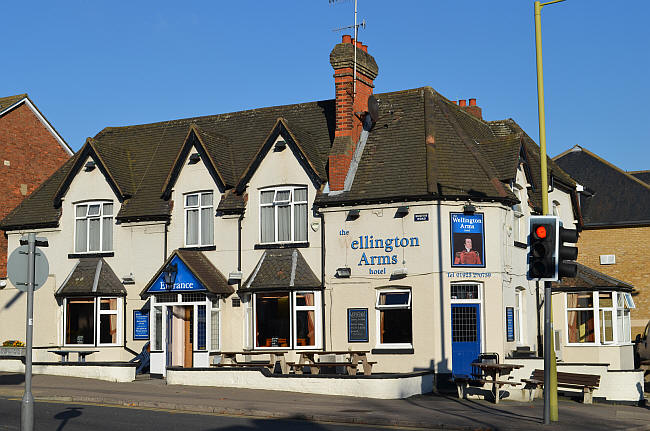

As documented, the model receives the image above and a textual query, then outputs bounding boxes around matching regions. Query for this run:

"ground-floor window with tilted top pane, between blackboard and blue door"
[376,289,413,348]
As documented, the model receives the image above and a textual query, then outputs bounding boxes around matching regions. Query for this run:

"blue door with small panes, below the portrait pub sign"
[451,304,481,376]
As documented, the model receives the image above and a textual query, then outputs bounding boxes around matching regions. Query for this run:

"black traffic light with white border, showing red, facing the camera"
[528,216,557,281]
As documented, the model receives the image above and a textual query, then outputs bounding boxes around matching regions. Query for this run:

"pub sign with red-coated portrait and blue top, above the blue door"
[450,213,485,268]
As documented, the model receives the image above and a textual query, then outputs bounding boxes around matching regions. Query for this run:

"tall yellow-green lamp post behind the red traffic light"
[534,0,565,424]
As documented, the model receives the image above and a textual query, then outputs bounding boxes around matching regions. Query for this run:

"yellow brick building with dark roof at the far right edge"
[554,145,650,338]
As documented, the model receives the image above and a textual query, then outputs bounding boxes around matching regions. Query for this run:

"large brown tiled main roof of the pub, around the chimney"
[0,87,571,230]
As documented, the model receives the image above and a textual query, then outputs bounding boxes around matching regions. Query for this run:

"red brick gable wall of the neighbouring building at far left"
[0,103,70,278]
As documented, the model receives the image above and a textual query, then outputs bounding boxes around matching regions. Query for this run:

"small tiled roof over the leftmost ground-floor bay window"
[55,258,126,297]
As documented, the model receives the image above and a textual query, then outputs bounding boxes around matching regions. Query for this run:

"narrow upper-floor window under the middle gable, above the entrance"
[185,192,214,246]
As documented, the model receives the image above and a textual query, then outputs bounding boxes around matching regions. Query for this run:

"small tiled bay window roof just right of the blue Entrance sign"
[242,248,321,291]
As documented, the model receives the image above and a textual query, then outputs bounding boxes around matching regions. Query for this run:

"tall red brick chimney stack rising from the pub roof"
[329,35,379,191]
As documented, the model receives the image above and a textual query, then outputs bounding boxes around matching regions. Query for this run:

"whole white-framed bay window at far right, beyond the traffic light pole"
[566,291,635,345]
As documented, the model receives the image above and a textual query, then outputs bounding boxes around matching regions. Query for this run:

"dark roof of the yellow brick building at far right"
[555,146,650,227]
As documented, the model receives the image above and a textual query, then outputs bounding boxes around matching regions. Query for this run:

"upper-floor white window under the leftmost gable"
[74,202,113,253]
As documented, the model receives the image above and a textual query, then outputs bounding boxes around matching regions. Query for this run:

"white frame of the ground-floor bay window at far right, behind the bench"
[564,290,635,346]
